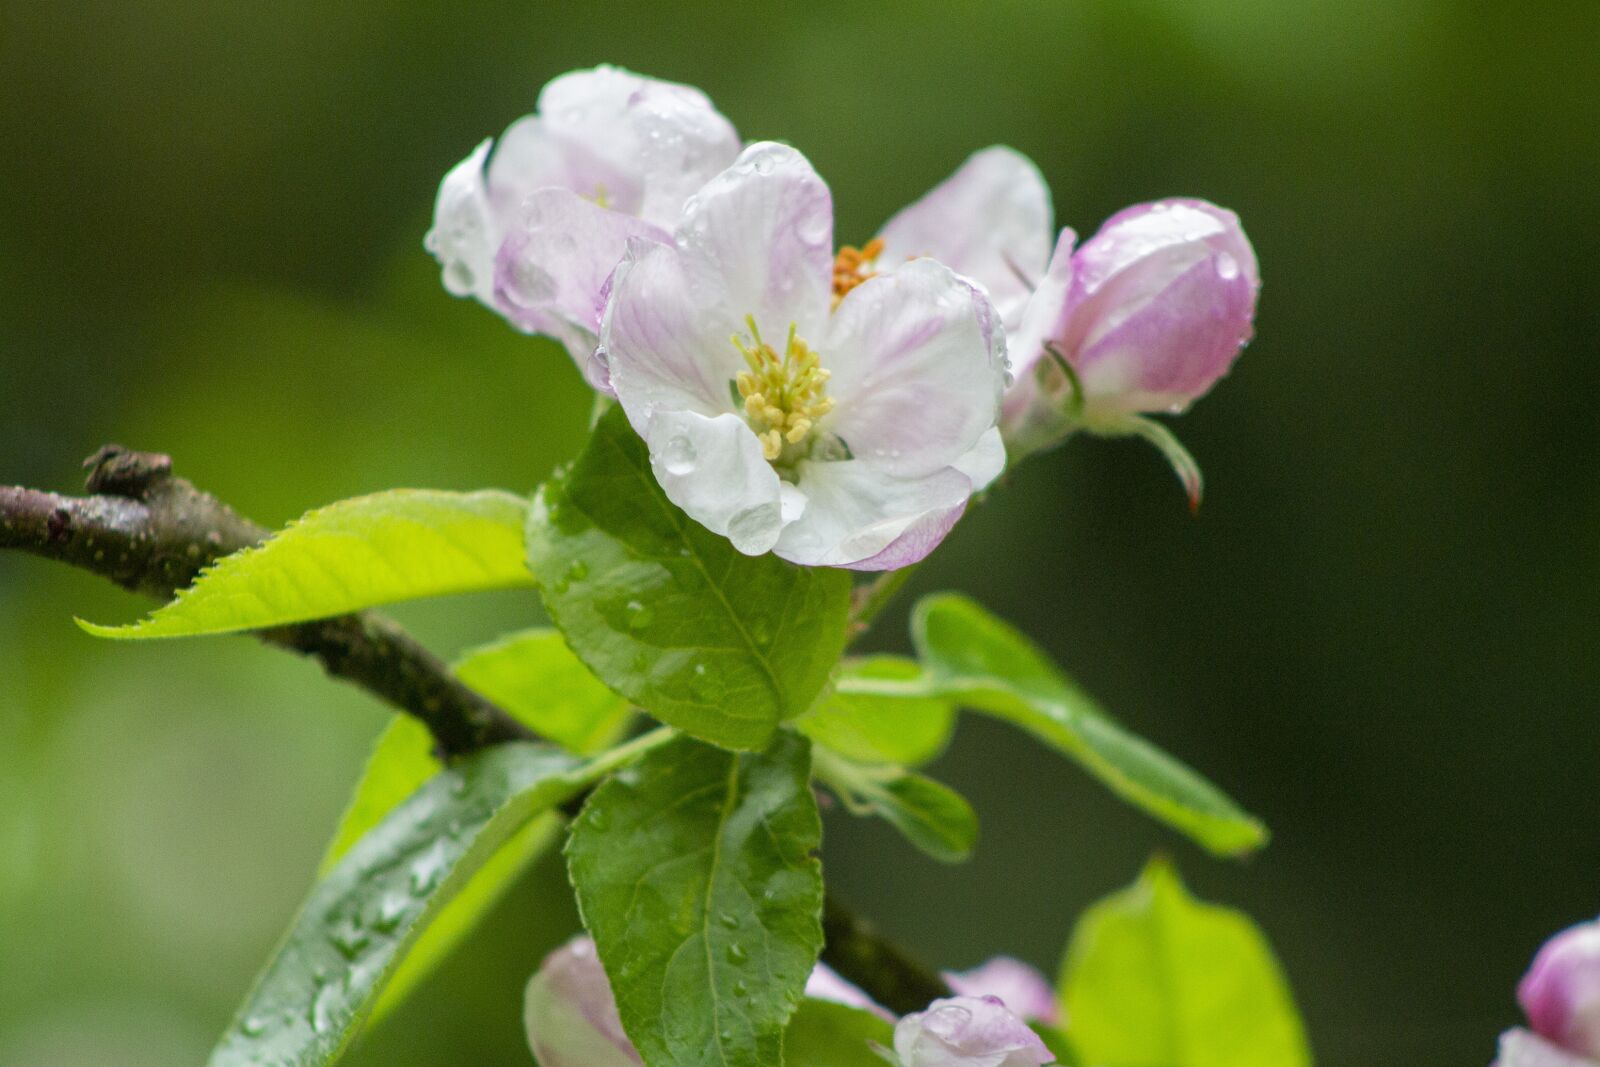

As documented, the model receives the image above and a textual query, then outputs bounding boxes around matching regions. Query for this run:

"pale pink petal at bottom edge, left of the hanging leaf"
[523,937,643,1067]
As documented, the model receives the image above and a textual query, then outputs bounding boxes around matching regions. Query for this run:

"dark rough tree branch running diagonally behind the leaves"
[0,445,950,1014]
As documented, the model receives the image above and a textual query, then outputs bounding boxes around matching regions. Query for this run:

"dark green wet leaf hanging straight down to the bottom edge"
[566,731,822,1067]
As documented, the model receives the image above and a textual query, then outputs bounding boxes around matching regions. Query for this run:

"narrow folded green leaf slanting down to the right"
[908,593,1267,856]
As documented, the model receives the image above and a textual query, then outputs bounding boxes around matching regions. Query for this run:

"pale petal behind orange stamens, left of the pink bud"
[878,146,1053,328]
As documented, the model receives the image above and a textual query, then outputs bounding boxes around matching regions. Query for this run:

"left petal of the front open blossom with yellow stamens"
[600,242,744,434]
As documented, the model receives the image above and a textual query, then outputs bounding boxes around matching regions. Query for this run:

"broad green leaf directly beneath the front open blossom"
[528,408,850,750]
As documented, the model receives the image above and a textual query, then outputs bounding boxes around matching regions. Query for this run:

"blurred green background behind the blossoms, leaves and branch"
[0,0,1600,1067]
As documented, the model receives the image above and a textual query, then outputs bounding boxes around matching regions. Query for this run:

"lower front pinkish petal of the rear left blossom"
[494,189,672,362]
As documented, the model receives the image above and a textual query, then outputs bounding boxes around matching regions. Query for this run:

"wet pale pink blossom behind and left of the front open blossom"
[424,66,739,363]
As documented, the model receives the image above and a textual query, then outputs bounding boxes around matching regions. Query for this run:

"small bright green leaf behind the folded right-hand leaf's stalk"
[795,656,955,766]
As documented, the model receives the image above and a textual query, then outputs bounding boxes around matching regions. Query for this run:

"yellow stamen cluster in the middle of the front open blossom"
[733,315,834,464]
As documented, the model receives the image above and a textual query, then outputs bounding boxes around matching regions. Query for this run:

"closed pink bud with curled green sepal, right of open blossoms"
[1003,200,1261,502]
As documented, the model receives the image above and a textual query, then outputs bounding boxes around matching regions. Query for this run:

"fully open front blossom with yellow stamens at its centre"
[592,142,1005,569]
